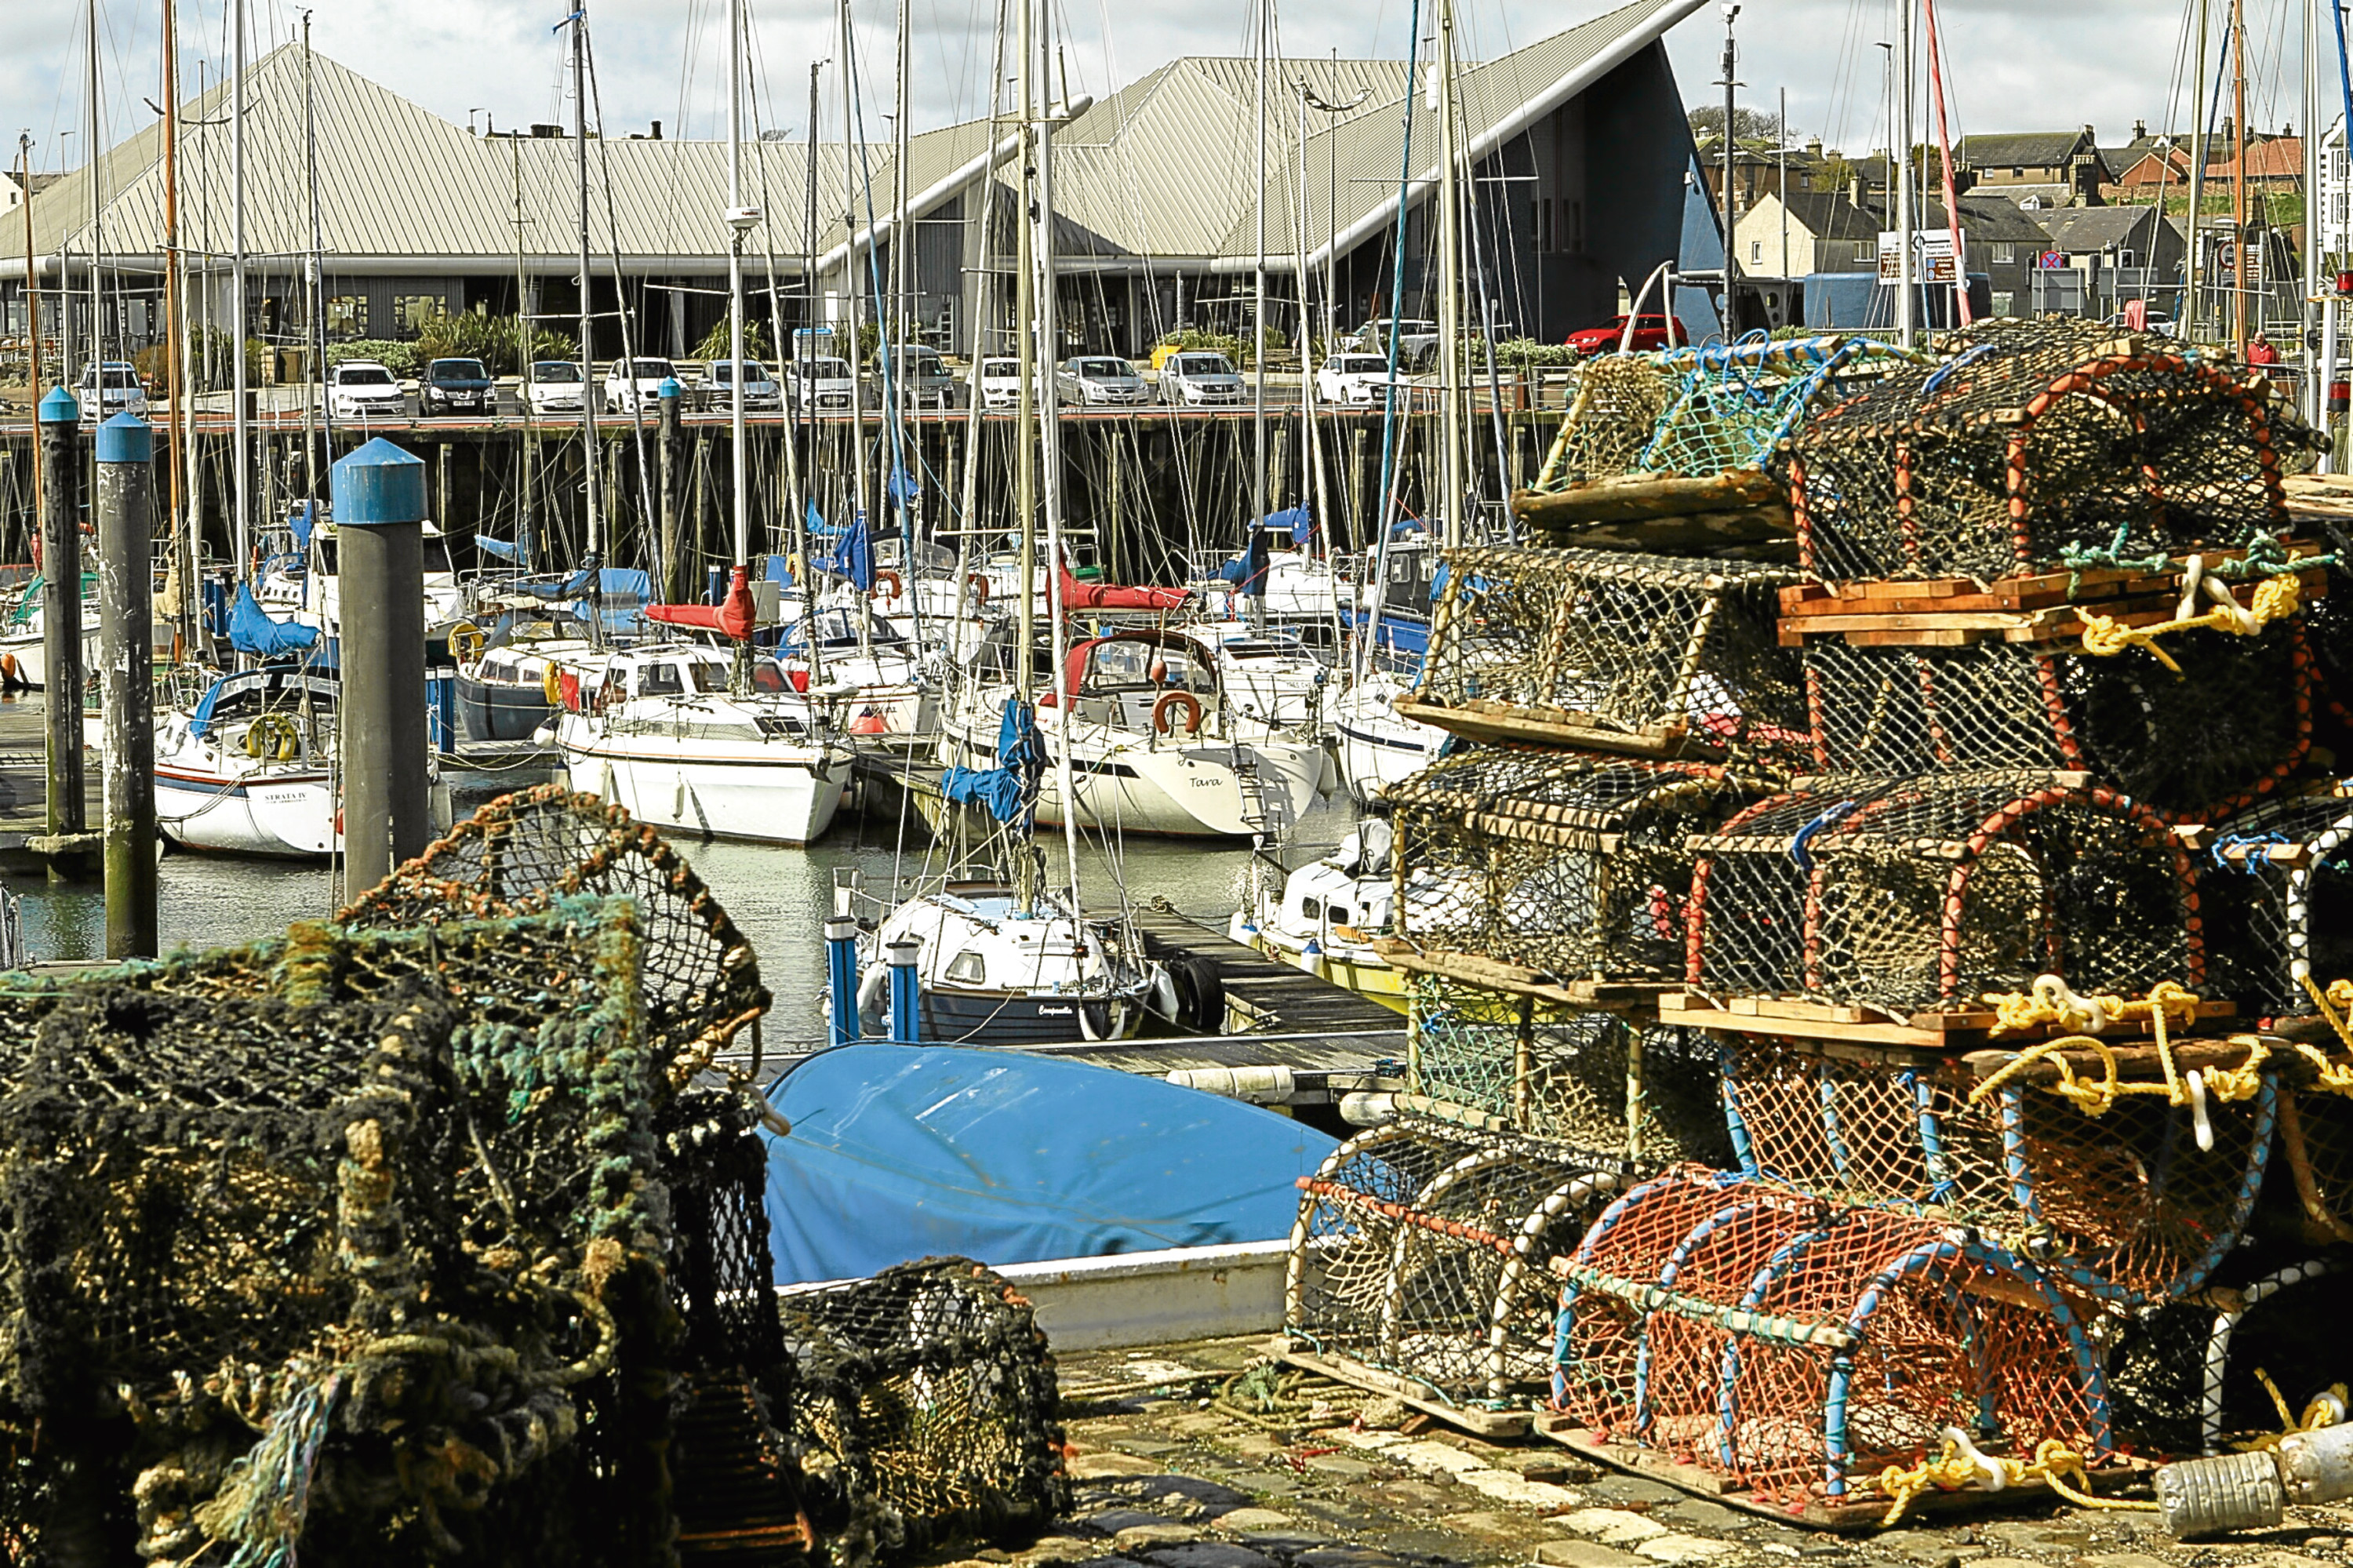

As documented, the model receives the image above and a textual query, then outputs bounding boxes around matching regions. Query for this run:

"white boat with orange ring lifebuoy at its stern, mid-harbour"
[941,631,1325,839]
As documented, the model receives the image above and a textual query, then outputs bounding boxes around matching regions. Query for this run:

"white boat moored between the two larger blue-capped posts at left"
[155,668,341,860]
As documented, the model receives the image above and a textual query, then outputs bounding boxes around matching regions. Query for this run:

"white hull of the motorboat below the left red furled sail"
[558,725,849,848]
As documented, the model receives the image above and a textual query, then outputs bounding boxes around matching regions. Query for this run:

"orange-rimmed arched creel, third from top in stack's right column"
[1687,772,2202,1015]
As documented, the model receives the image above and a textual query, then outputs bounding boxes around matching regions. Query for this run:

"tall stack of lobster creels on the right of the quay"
[1289,320,2353,1526]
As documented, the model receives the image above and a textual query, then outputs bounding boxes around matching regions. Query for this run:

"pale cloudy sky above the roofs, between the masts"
[0,0,2334,167]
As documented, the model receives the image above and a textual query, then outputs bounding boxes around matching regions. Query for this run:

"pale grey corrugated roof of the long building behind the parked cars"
[23,0,1701,273]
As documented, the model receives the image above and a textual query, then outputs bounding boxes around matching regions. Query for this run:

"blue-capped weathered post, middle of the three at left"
[94,414,155,959]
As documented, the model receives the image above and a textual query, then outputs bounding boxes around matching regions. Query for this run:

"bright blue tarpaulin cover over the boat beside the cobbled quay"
[760,1046,1337,1286]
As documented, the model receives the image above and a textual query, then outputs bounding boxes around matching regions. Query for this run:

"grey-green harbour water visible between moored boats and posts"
[7,692,1355,1046]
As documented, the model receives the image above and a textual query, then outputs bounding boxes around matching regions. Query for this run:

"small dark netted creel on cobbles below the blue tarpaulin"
[784,1257,1068,1568]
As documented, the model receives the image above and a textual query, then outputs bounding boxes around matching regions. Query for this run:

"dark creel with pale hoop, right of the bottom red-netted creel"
[2108,1248,2353,1455]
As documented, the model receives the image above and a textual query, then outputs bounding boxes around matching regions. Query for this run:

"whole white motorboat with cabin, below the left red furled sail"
[541,642,849,846]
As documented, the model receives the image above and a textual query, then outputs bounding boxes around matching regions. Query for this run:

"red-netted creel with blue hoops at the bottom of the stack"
[1553,1170,2108,1507]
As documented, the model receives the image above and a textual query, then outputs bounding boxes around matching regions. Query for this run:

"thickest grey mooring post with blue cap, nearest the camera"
[327,435,431,897]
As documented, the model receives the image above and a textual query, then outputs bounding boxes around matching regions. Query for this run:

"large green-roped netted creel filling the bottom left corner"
[0,900,696,1563]
